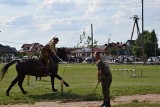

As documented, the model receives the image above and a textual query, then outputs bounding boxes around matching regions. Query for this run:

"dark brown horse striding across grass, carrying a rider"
[0,48,69,96]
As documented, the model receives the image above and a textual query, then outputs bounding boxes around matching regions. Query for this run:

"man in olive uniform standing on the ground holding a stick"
[94,52,112,107]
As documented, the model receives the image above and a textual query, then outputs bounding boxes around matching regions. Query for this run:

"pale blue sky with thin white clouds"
[0,0,160,50]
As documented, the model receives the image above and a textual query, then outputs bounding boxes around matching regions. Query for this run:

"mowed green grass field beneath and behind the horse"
[0,64,160,107]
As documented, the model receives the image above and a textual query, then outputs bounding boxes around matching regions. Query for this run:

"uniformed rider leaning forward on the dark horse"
[40,37,59,76]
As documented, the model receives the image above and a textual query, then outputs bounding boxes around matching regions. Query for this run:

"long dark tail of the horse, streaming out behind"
[0,60,20,81]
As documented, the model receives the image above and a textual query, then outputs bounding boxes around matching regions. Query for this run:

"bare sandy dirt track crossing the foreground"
[0,94,160,107]
